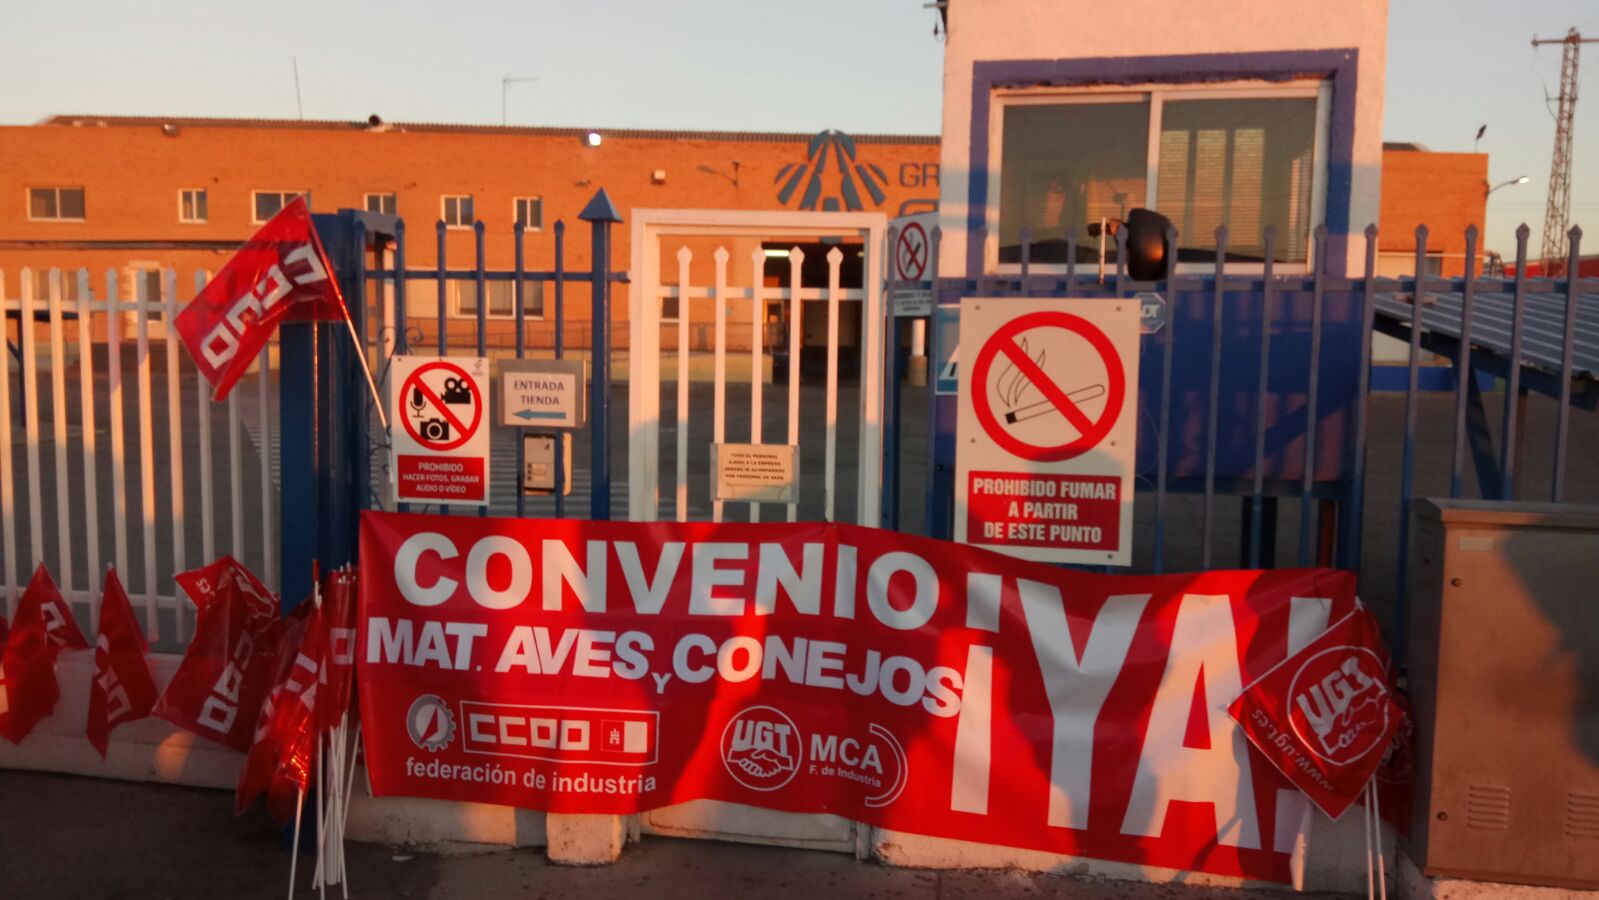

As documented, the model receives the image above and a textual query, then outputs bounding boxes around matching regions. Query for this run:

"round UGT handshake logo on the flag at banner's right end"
[1289,646,1390,766]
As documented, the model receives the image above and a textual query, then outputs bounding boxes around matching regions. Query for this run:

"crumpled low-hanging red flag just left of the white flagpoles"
[233,606,328,822]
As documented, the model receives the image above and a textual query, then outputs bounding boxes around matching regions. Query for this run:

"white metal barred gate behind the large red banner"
[628,209,887,852]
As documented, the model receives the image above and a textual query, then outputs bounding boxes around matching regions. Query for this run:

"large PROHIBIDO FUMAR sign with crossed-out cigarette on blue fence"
[955,299,1138,566]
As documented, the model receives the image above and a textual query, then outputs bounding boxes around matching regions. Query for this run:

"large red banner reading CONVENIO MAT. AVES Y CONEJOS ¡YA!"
[357,513,1354,881]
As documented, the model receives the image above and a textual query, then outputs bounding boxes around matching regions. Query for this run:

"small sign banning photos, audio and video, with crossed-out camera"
[389,356,489,505]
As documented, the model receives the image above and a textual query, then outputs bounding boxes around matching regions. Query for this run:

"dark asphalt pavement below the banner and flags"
[0,771,1362,900]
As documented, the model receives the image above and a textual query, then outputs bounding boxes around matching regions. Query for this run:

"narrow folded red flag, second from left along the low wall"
[88,569,157,759]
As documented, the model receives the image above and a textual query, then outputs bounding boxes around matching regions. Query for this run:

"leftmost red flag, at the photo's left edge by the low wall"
[0,564,90,743]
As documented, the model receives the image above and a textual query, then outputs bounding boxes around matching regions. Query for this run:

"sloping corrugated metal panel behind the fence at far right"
[1377,291,1599,379]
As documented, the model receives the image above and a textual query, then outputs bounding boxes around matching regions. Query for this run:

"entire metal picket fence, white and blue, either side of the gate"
[0,206,1599,668]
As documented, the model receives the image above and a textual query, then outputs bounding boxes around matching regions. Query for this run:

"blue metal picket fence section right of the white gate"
[908,219,1599,661]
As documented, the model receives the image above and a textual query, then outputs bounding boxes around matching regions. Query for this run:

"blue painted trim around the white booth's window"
[966,48,1359,278]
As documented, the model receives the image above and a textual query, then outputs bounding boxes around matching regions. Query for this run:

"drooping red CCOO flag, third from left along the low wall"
[155,556,283,751]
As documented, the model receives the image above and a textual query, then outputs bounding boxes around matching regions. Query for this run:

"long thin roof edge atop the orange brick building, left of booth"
[38,115,939,144]
